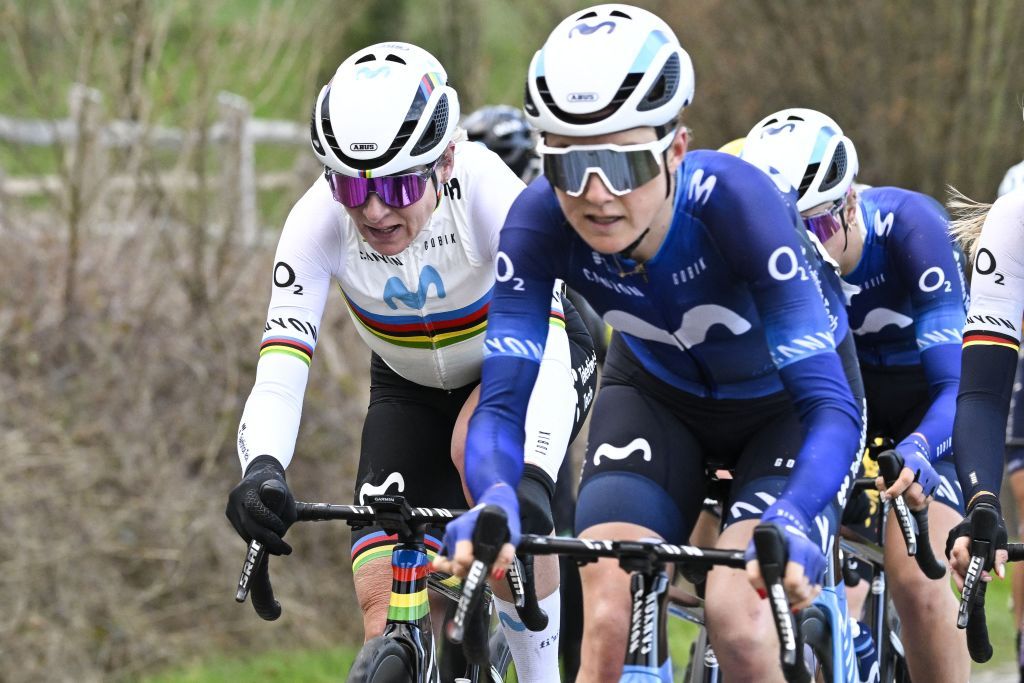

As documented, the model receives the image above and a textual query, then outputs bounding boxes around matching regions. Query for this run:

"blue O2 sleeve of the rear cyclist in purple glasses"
[888,197,967,462]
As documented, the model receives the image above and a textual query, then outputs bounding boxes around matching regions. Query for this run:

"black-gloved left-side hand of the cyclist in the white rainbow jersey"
[224,456,296,555]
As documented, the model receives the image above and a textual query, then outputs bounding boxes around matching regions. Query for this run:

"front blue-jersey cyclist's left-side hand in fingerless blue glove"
[433,484,519,579]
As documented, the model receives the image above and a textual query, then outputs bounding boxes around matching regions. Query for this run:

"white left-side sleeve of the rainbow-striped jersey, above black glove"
[238,178,341,471]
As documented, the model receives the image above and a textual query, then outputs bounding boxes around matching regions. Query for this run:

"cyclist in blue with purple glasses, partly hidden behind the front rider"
[741,109,971,681]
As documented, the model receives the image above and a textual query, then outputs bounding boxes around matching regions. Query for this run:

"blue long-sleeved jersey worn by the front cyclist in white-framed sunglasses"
[467,152,860,518]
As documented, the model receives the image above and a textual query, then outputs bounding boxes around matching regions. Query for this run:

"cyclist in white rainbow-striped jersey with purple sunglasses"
[227,42,593,681]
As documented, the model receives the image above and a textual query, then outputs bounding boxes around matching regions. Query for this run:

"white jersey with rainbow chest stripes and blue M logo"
[238,142,574,470]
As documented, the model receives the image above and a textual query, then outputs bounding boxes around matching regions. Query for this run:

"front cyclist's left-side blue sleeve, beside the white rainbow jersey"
[466,178,567,500]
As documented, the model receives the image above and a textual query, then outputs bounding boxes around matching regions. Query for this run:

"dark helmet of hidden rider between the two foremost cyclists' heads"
[462,104,540,182]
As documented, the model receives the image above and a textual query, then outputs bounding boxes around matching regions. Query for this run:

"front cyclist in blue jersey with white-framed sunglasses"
[437,4,861,681]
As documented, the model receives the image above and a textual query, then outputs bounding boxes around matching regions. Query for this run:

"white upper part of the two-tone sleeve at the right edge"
[964,187,1024,345]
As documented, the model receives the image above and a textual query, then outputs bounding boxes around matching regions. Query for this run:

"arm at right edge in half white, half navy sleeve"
[953,190,1024,509]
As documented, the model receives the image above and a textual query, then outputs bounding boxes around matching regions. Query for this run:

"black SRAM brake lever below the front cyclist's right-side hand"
[754,523,811,683]
